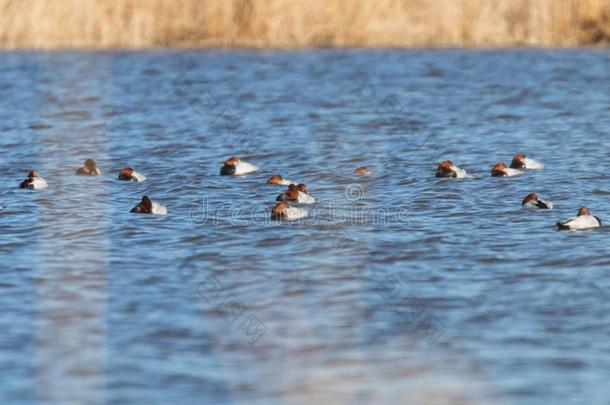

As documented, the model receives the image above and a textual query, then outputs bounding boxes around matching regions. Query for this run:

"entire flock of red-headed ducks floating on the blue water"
[9,154,602,230]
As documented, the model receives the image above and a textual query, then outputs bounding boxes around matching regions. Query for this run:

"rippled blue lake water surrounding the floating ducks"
[0,49,610,404]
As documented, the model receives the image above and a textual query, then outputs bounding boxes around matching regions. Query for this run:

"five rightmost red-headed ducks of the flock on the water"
[436,154,602,230]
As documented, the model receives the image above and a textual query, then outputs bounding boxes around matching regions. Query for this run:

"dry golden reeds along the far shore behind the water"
[0,0,610,50]
